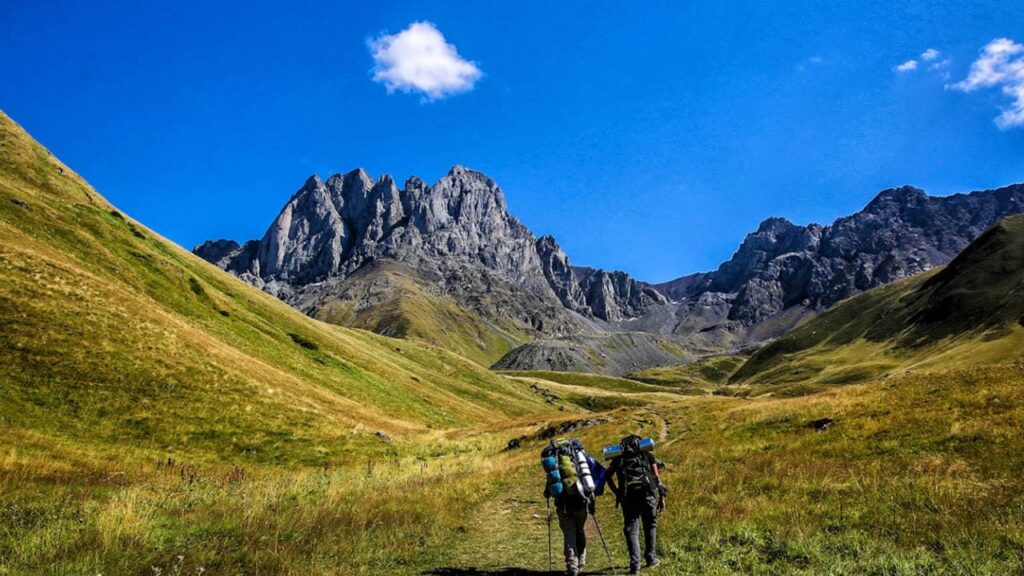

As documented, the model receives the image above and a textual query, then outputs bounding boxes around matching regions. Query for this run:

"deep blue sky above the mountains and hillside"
[0,0,1024,281]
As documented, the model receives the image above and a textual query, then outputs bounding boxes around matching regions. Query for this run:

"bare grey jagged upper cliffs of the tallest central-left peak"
[195,166,547,293]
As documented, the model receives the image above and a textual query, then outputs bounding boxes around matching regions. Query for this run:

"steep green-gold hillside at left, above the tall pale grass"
[0,113,552,465]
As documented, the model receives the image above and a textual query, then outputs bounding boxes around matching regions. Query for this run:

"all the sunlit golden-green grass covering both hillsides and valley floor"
[0,108,1024,576]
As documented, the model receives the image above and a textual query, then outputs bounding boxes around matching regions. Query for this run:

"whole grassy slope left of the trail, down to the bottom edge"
[0,108,573,575]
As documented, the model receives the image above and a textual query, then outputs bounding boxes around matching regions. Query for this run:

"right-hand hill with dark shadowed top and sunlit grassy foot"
[732,215,1024,384]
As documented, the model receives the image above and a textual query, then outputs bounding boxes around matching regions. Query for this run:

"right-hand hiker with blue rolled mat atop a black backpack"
[605,435,667,574]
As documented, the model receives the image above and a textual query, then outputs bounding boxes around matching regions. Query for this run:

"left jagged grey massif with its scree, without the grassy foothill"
[194,166,666,358]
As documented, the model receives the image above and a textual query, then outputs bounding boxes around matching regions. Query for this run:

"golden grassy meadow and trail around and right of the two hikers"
[440,366,1024,576]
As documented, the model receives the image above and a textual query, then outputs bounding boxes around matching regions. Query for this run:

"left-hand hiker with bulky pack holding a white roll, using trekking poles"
[541,439,604,576]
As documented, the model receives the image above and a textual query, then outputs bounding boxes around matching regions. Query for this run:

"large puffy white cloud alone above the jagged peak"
[368,22,483,100]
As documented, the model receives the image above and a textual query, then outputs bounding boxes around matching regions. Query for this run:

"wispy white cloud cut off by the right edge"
[948,38,1024,130]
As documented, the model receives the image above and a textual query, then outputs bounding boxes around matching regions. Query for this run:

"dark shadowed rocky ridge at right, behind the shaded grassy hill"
[655,184,1024,330]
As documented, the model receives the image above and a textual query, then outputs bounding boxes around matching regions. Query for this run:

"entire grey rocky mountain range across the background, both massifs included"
[195,166,1024,373]
